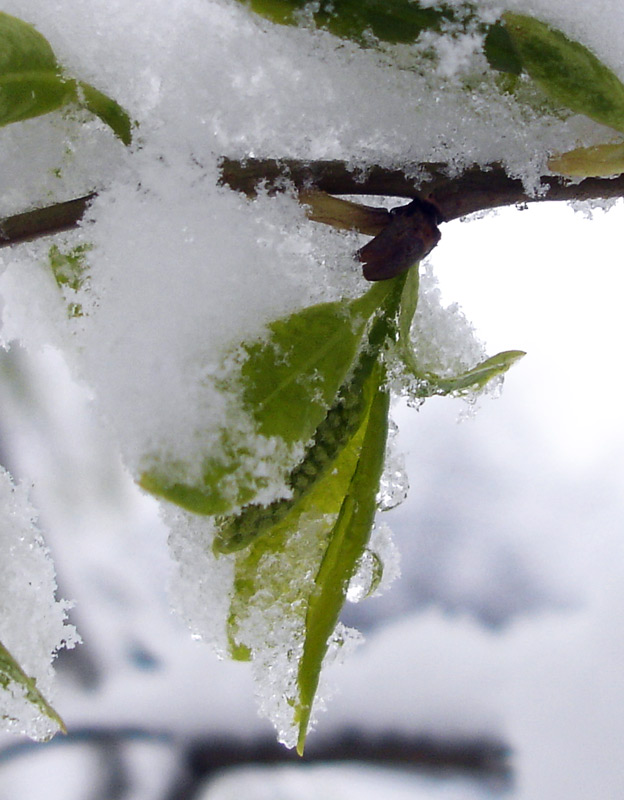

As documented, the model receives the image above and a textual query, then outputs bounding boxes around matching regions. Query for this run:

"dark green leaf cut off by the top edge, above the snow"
[240,0,471,46]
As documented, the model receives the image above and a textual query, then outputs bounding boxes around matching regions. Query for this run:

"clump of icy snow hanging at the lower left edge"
[0,470,79,740]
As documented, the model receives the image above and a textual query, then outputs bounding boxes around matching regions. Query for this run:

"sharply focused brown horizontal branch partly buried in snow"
[0,158,624,247]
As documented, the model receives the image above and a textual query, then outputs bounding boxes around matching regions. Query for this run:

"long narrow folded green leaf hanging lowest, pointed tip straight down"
[295,365,390,755]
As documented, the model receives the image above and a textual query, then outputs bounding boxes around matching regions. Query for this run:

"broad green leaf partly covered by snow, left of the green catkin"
[140,282,392,520]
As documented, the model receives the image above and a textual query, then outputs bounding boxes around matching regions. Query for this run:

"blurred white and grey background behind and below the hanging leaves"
[0,198,624,800]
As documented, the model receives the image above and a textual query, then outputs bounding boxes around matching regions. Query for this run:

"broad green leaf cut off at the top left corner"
[0,12,75,126]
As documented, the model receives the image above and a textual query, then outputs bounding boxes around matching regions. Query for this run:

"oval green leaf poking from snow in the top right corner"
[503,12,624,131]
